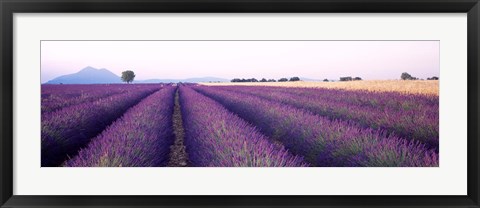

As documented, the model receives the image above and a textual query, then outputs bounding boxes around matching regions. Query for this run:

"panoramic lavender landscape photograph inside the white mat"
[39,40,440,168]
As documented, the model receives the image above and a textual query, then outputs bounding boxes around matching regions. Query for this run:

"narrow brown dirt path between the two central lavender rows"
[167,89,190,167]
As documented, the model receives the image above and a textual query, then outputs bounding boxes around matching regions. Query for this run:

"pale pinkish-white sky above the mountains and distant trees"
[41,41,440,83]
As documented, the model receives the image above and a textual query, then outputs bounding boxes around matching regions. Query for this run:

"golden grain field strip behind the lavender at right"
[200,80,439,96]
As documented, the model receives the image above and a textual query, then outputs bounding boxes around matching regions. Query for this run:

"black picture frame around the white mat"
[0,0,480,207]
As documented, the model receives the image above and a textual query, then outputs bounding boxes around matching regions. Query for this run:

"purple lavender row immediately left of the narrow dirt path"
[64,86,176,167]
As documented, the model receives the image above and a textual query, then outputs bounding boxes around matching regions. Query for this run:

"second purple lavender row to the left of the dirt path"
[41,85,160,167]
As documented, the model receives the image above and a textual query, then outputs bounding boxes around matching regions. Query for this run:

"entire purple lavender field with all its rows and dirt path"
[41,84,439,167]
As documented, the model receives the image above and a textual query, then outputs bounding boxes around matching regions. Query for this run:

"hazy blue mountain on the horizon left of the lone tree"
[45,66,122,84]
